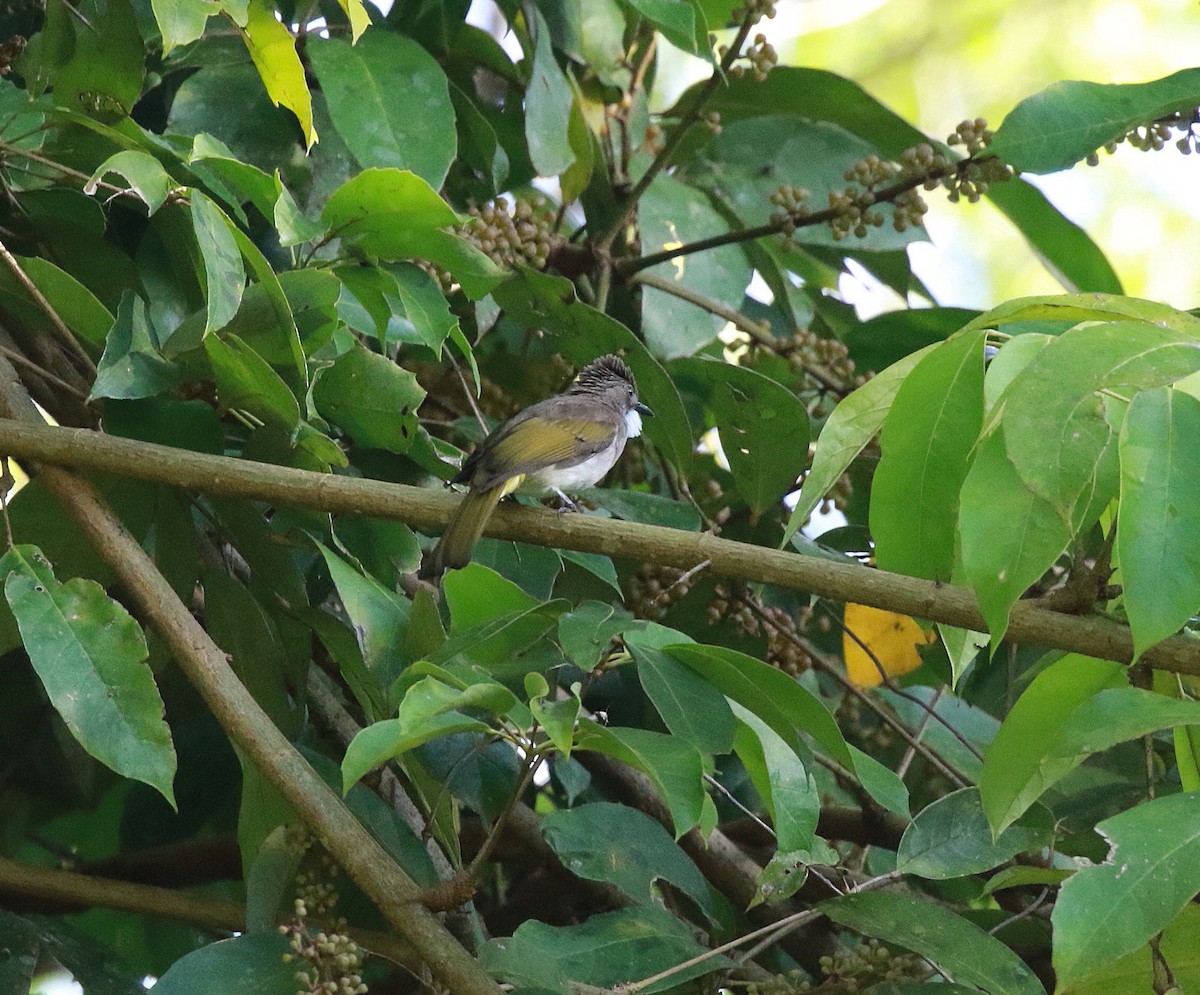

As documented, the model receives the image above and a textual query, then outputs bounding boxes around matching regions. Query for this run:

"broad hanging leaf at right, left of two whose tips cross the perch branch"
[959,431,1073,646]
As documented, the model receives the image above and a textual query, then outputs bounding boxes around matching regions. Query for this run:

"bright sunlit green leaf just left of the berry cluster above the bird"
[322,169,505,299]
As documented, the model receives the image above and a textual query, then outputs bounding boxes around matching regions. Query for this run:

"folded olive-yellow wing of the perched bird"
[468,414,618,488]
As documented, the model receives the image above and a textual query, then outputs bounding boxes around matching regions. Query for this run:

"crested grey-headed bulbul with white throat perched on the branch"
[418,355,653,579]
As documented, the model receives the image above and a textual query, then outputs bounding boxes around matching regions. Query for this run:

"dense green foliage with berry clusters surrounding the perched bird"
[0,0,1200,995]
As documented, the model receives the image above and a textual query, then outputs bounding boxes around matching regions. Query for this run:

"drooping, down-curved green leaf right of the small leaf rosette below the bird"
[575,719,706,839]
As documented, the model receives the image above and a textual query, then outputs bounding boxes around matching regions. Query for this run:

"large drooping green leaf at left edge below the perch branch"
[0,546,175,808]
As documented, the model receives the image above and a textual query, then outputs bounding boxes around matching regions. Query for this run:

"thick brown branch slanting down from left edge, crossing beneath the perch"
[0,379,499,995]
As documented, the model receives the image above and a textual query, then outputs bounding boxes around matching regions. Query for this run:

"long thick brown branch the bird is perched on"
[0,420,1200,688]
